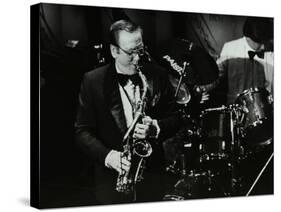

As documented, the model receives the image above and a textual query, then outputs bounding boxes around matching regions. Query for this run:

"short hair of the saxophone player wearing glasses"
[109,20,142,45]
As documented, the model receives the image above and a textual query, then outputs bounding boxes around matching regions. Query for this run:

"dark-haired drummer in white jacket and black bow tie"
[217,17,273,104]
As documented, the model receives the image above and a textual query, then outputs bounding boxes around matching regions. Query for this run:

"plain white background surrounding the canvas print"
[0,0,281,212]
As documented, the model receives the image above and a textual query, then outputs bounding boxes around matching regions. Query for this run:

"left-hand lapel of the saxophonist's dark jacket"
[104,64,127,135]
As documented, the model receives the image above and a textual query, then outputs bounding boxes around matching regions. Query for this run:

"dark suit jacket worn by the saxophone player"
[75,64,180,204]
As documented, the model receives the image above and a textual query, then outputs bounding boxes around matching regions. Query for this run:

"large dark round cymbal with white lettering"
[160,39,219,85]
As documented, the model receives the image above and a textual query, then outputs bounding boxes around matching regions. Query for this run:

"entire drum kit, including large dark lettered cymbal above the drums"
[161,39,273,200]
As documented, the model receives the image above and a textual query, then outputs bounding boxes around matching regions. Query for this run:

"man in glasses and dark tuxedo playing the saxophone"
[75,20,181,204]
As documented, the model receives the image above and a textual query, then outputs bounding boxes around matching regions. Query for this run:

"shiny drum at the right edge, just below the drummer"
[236,88,273,147]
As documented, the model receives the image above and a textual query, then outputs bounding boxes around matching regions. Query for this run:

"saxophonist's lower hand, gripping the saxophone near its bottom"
[105,150,131,174]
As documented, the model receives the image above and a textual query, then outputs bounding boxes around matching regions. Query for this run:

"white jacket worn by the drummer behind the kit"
[217,37,274,104]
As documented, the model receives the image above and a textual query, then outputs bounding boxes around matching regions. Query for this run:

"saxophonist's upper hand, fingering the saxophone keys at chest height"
[133,116,160,139]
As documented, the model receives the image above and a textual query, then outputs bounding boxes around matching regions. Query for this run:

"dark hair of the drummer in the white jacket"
[243,17,273,43]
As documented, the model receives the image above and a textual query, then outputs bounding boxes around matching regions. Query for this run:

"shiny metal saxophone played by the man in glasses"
[116,65,152,194]
